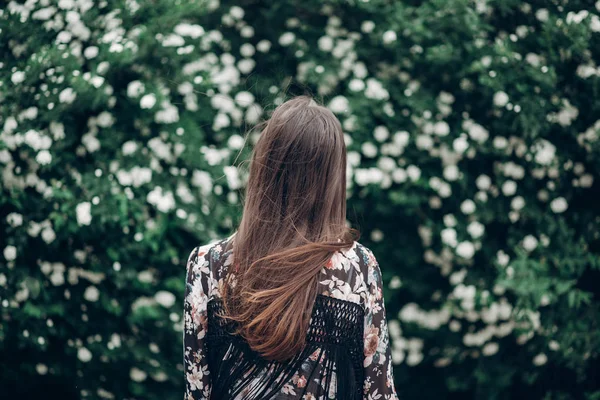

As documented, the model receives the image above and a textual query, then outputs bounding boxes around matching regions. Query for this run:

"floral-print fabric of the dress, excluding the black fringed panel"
[183,235,398,400]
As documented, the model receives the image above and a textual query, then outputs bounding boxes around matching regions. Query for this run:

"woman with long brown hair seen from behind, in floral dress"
[184,96,398,400]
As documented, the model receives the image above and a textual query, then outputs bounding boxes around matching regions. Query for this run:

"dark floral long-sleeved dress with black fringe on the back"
[183,235,398,400]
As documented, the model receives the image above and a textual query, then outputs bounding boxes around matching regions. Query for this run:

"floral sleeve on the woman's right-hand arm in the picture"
[363,249,398,400]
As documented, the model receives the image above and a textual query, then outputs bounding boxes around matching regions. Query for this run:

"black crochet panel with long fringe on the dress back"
[204,294,364,400]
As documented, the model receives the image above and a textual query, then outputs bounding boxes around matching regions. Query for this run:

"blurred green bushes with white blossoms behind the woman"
[0,0,600,400]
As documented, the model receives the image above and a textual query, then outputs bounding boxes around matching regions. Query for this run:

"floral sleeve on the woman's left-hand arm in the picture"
[183,247,212,400]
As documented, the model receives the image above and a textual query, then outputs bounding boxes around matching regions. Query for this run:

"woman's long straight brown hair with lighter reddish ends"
[221,96,358,361]
